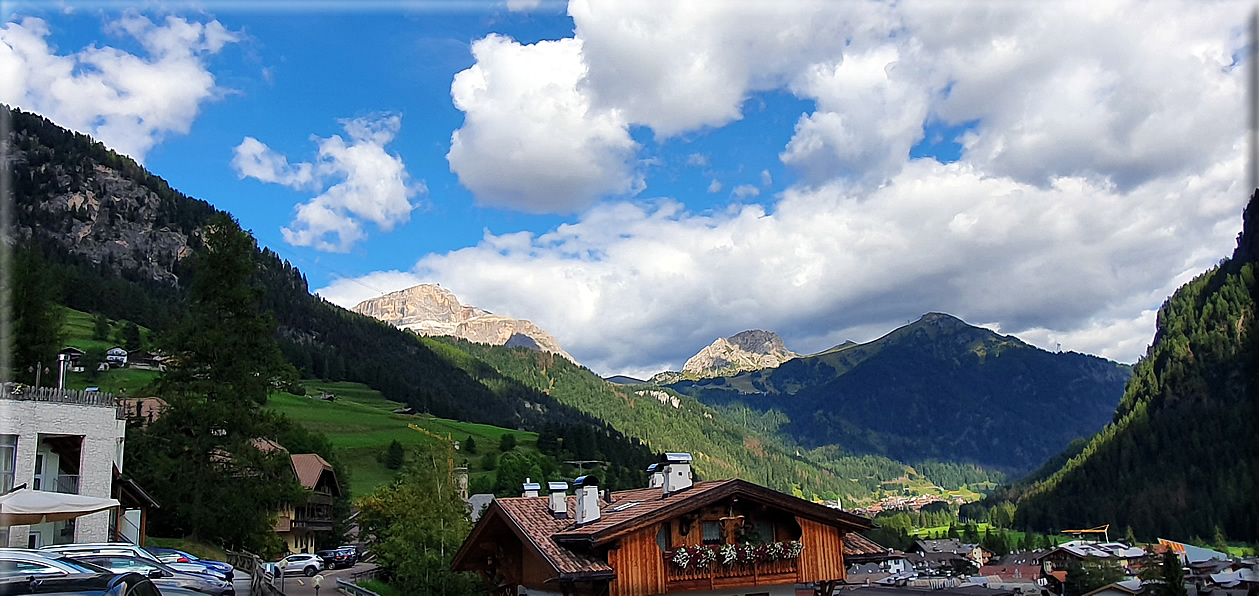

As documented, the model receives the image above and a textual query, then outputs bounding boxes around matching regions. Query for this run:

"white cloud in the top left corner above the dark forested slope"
[0,13,242,161]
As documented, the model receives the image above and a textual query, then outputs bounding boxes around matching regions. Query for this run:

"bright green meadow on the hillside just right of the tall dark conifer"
[267,381,538,496]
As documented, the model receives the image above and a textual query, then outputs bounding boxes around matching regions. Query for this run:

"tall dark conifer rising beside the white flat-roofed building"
[126,214,302,548]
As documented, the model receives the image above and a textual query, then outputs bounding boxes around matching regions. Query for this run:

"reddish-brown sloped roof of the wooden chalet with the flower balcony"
[452,479,881,580]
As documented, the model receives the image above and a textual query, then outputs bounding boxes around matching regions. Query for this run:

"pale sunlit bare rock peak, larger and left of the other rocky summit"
[351,284,577,363]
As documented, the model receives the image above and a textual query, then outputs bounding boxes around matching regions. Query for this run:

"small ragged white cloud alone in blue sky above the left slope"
[232,113,427,252]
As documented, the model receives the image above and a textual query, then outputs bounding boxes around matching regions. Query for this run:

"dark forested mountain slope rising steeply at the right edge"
[1016,190,1259,541]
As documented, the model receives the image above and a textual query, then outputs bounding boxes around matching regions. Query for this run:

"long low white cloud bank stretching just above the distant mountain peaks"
[319,151,1244,372]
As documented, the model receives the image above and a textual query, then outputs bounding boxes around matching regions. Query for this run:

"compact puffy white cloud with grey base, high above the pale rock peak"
[446,35,637,213]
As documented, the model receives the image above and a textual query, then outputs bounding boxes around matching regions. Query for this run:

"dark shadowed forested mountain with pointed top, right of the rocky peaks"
[667,312,1131,473]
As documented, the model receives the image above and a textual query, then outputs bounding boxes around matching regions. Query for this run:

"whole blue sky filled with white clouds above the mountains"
[7,0,1251,375]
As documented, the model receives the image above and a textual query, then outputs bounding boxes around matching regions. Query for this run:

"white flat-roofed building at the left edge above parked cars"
[0,386,129,547]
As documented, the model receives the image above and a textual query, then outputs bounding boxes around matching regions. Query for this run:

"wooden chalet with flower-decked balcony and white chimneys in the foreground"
[451,454,871,596]
